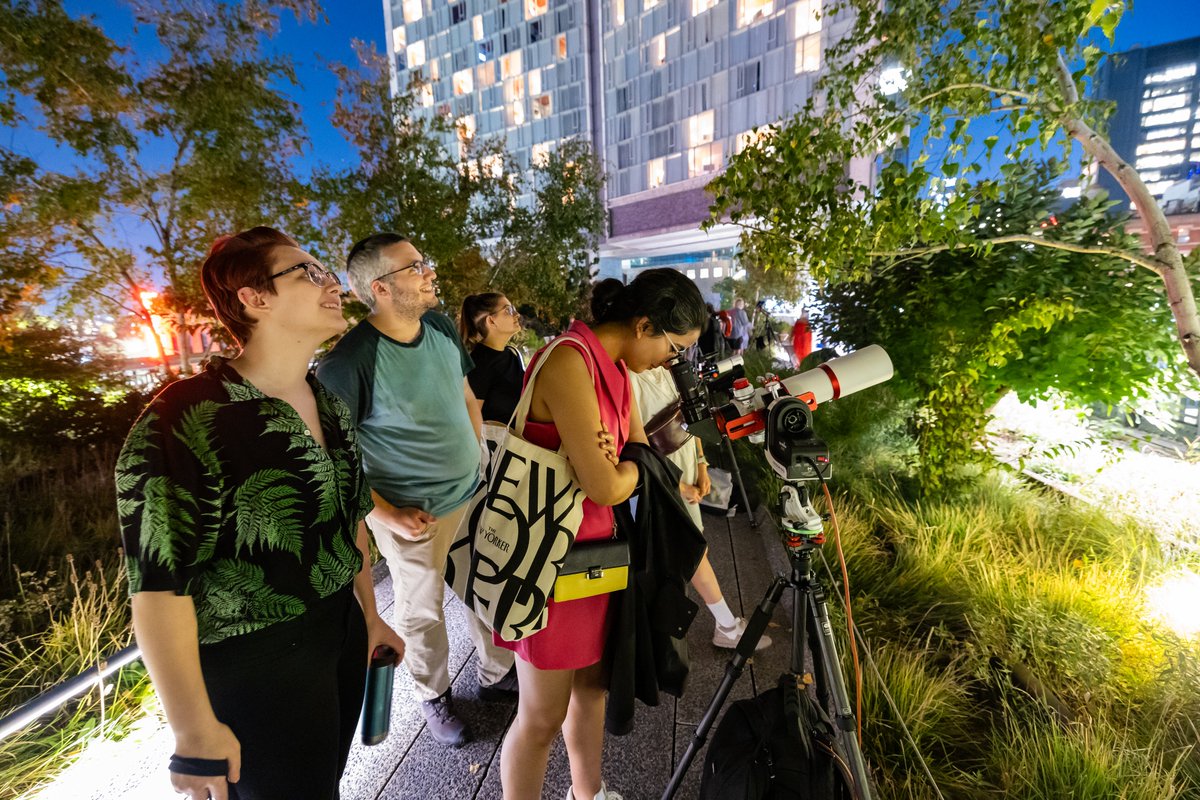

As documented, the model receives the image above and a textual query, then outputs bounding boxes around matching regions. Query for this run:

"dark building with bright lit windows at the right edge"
[1096,37,1200,206]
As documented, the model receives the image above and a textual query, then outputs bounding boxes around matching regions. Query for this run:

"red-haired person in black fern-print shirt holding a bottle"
[116,228,404,800]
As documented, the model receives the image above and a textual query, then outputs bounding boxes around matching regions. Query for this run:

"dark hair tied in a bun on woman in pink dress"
[592,267,708,333]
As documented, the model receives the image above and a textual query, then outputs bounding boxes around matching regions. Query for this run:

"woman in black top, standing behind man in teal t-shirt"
[458,291,524,423]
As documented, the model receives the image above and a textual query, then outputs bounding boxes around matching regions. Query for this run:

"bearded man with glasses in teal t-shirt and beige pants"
[317,234,516,746]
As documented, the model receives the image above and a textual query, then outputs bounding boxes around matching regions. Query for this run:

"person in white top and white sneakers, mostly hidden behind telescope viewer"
[631,367,770,650]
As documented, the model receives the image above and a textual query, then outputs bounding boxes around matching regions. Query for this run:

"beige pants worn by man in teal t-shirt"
[367,504,514,700]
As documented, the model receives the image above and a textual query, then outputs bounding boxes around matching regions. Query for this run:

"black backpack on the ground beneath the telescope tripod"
[700,674,856,800]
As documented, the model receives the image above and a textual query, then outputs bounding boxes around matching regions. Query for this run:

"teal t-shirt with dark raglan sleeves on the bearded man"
[317,311,480,516]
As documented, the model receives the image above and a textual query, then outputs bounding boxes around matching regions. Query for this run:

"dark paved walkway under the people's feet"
[342,511,791,800]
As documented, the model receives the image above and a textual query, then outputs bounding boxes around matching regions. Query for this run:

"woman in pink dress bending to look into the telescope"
[496,269,708,800]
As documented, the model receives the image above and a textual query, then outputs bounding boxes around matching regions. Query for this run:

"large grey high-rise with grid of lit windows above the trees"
[384,0,845,299]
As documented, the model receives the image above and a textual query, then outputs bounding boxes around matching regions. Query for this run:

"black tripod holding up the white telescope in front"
[662,481,874,800]
